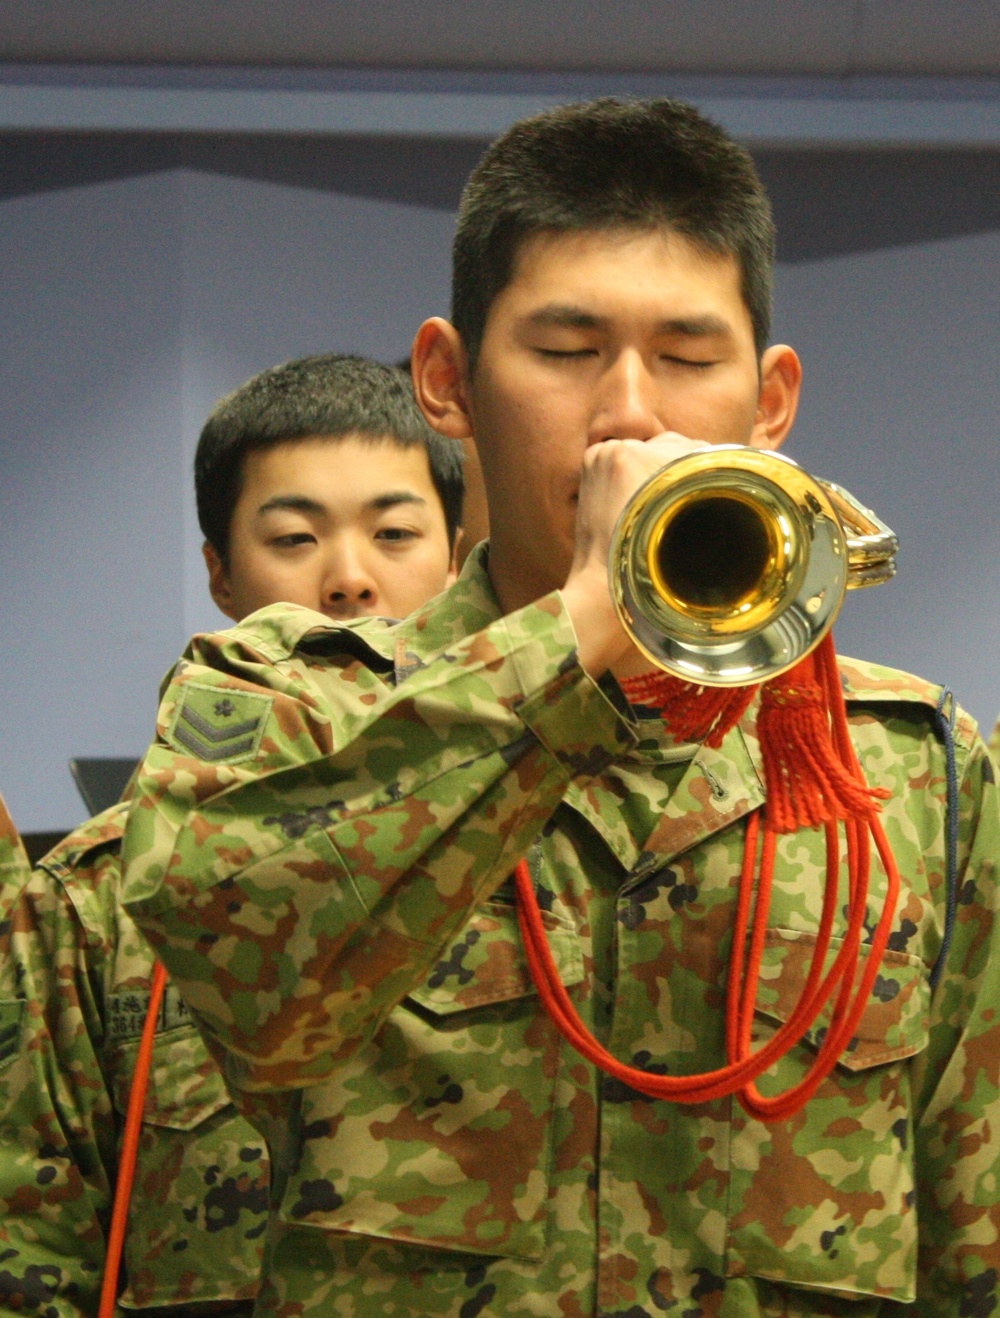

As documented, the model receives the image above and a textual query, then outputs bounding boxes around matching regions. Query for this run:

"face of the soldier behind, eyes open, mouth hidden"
[206,436,453,621]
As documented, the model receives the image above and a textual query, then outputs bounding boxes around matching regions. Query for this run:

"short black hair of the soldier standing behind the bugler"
[195,353,465,567]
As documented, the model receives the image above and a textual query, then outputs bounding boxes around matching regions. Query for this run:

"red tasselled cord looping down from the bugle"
[514,637,900,1122]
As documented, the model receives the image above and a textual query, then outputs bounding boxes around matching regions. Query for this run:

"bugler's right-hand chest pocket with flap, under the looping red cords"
[727,929,930,1311]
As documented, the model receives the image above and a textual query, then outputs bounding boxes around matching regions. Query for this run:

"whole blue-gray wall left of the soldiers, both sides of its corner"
[0,171,452,832]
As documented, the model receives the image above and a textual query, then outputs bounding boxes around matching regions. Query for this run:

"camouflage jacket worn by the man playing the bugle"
[125,560,1000,1318]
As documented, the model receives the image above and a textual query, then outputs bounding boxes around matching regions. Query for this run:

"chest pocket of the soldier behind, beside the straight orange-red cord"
[111,985,270,1309]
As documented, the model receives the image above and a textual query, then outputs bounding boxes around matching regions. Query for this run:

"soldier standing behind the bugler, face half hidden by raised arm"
[0,356,462,1318]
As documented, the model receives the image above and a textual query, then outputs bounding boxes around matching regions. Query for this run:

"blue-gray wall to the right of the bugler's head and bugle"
[776,233,1000,731]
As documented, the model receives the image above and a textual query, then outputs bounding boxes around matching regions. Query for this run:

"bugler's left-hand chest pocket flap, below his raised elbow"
[408,902,584,1016]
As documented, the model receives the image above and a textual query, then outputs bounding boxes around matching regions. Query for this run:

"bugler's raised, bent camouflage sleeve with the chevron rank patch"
[125,596,632,1091]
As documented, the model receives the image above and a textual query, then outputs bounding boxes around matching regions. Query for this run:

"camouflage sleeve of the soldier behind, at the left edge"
[0,827,116,1318]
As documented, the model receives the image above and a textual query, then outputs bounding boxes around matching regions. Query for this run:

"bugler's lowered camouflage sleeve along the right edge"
[893,720,1000,1318]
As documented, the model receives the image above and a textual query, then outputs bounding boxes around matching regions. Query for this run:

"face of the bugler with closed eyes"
[465,229,772,606]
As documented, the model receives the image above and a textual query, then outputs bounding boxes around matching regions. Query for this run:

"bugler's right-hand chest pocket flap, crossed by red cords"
[755,929,930,1070]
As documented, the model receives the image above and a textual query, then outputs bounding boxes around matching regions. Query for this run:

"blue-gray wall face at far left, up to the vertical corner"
[0,179,182,830]
